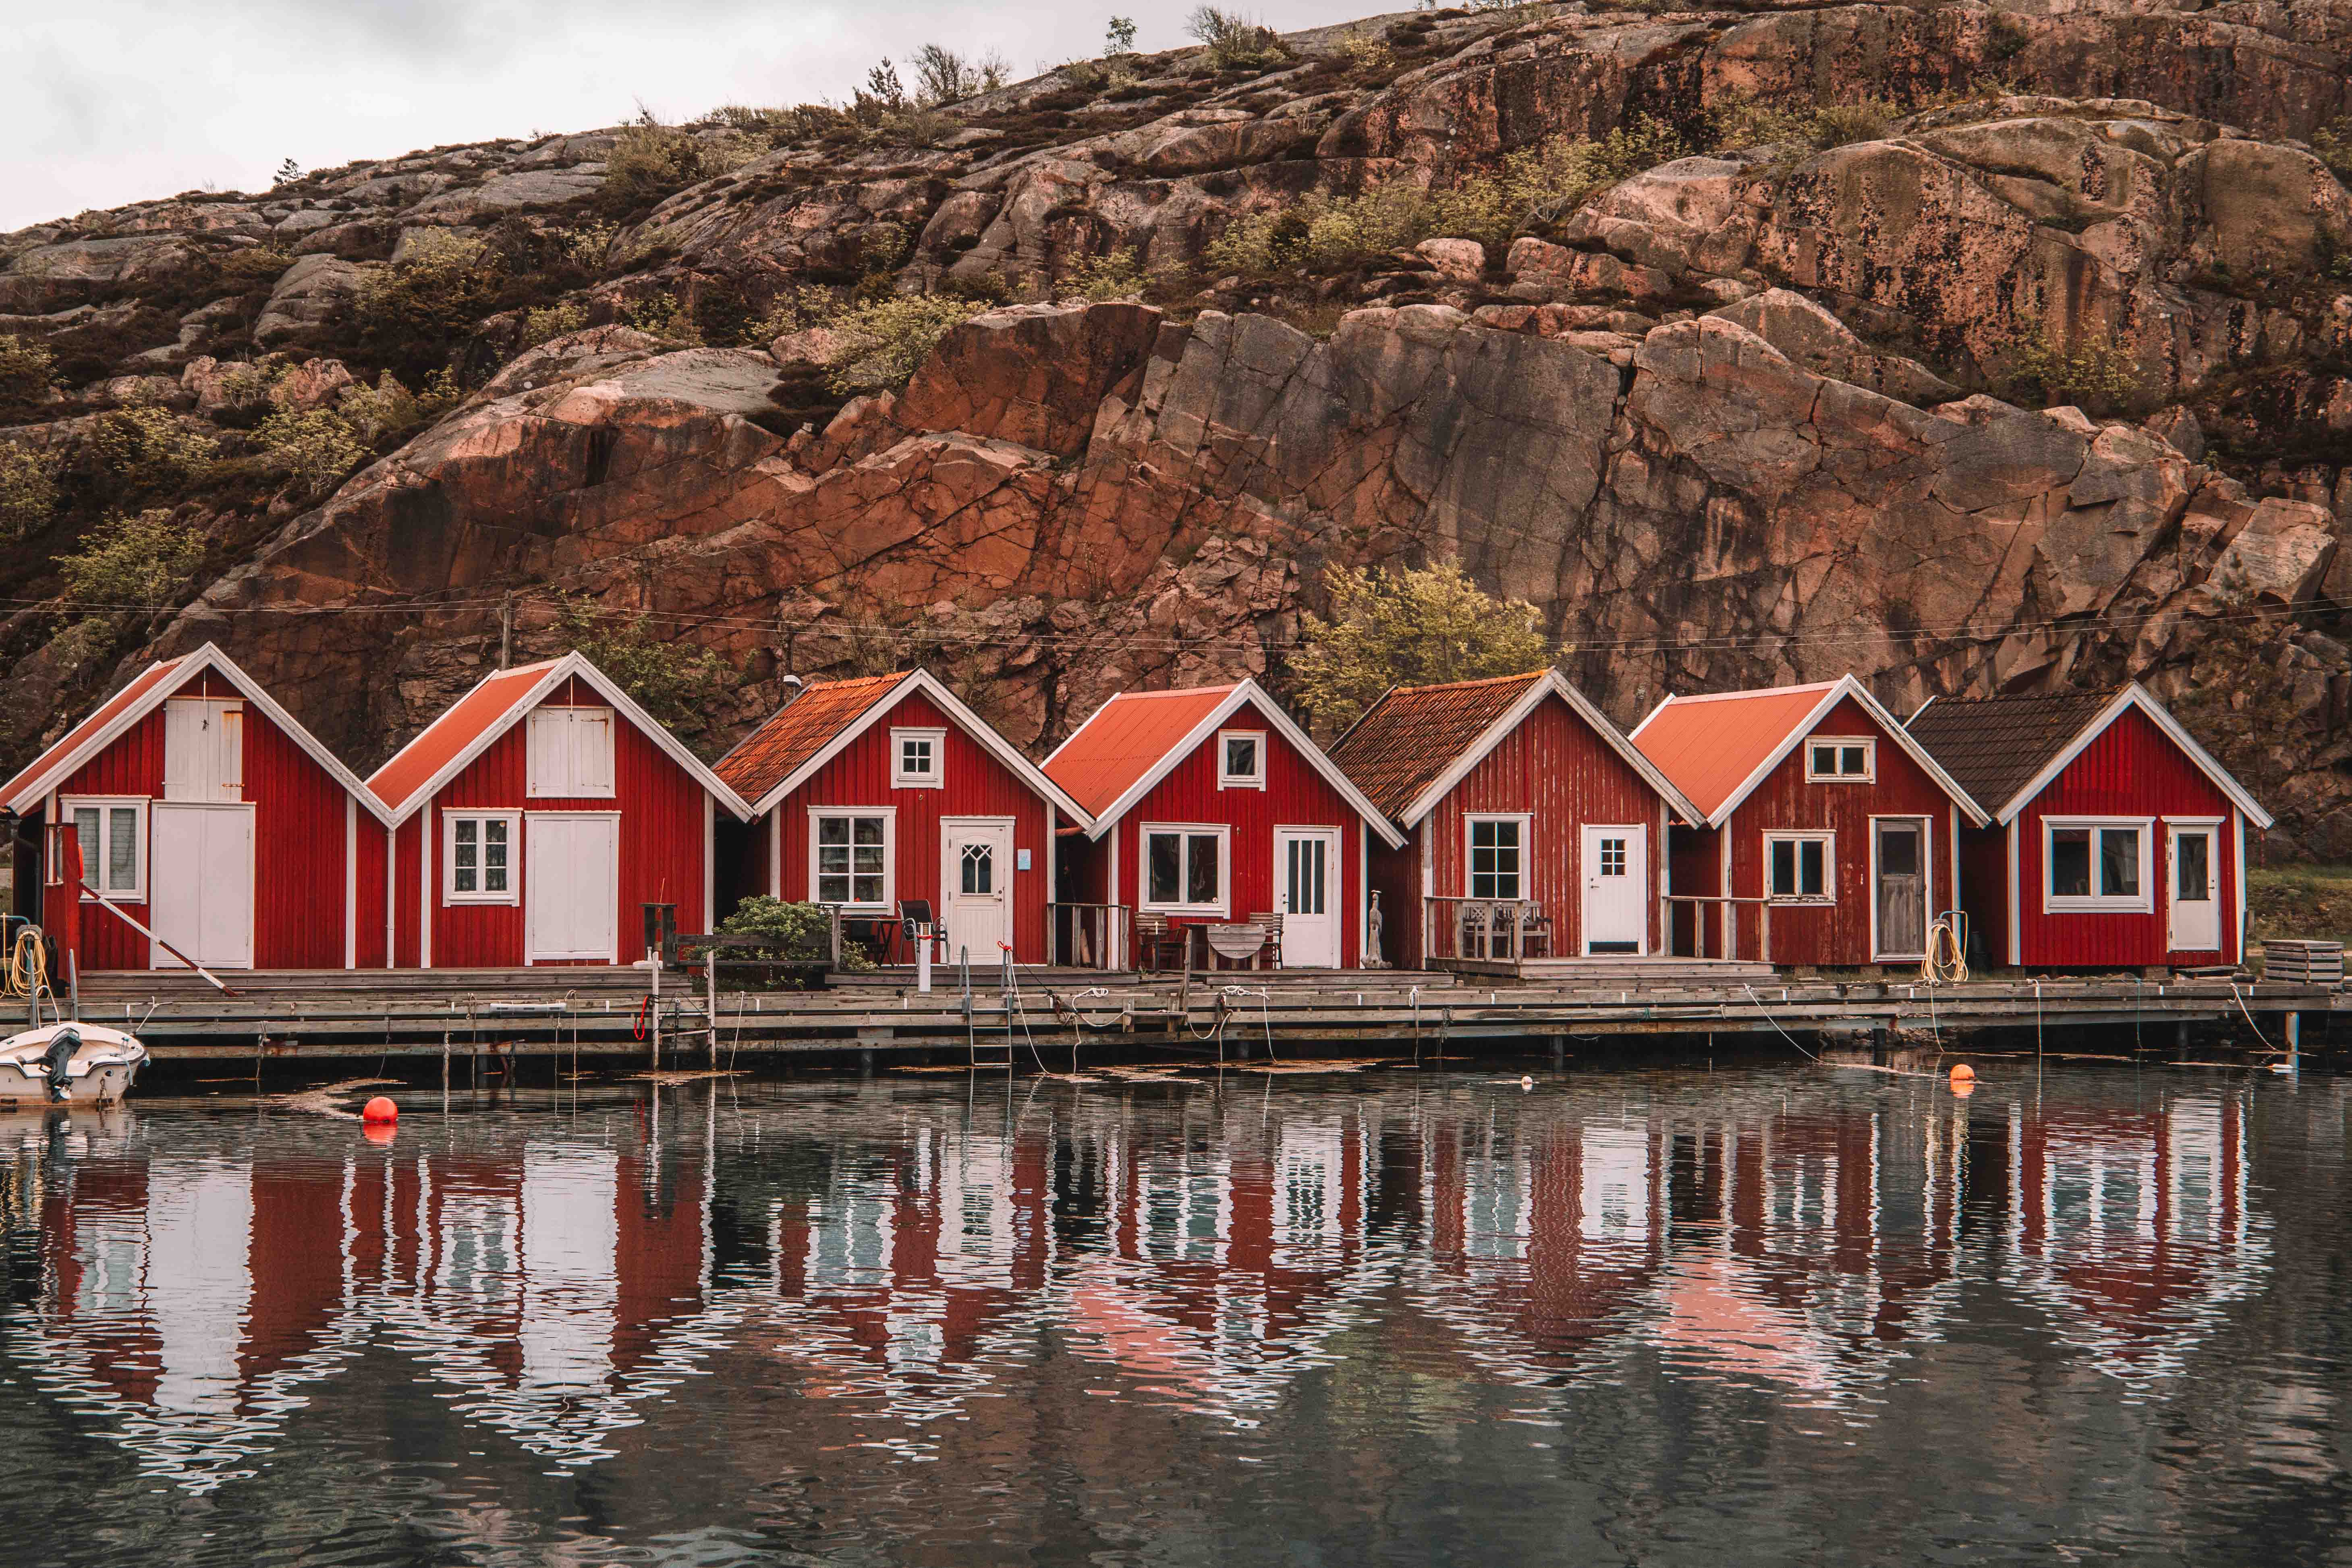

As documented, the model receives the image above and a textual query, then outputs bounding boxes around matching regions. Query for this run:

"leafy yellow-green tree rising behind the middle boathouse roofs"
[1291,562,1552,734]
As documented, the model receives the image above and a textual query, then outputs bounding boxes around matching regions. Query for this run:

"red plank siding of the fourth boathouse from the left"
[1096,691,1385,969]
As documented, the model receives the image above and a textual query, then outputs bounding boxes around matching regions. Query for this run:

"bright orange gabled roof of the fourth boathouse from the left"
[1044,679,1404,848]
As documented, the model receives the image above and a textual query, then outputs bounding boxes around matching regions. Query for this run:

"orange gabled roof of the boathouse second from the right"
[1632,675,1985,828]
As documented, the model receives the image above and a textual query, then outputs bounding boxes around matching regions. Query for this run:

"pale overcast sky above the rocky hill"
[0,0,1395,233]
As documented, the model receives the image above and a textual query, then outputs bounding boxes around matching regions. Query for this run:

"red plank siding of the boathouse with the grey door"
[1729,698,1957,966]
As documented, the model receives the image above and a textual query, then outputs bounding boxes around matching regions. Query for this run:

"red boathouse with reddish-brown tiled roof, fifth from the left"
[1331,670,1698,969]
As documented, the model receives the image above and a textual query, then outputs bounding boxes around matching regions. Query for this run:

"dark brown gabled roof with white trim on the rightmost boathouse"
[1905,682,2270,828]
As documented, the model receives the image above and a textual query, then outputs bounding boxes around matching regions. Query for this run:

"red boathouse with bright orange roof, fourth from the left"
[1044,679,1404,969]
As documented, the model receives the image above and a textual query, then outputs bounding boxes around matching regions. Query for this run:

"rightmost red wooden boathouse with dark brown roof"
[1908,684,2270,969]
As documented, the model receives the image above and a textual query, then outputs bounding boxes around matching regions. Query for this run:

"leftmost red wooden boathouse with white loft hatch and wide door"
[0,642,384,969]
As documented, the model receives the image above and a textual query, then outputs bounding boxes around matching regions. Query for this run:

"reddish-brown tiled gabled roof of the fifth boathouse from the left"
[1331,670,1698,828]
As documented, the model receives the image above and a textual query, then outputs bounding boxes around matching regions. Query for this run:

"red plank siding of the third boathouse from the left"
[764,691,1054,964]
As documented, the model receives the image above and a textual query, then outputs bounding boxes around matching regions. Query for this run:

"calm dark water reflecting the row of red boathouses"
[0,1062,2352,1566]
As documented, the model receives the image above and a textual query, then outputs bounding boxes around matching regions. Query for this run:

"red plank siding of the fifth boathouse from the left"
[1411,696,1665,954]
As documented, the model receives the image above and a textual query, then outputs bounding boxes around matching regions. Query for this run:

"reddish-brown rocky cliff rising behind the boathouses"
[0,0,2352,856]
